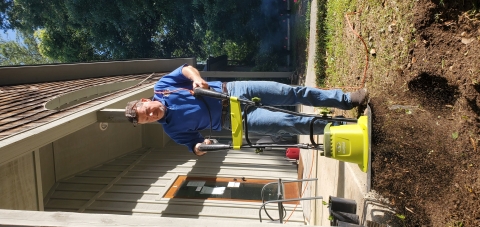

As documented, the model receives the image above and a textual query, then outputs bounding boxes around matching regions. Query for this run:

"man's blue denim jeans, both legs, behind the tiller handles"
[224,81,352,135]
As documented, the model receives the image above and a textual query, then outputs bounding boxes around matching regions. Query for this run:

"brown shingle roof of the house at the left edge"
[0,73,164,140]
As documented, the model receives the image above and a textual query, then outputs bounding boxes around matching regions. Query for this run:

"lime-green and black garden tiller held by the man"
[194,88,371,172]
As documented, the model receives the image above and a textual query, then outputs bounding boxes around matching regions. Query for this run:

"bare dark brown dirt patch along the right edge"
[369,0,480,226]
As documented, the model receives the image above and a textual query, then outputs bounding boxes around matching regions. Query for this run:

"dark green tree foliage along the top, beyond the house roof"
[0,0,286,68]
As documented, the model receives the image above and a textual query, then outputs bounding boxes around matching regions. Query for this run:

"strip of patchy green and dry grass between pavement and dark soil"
[315,0,415,92]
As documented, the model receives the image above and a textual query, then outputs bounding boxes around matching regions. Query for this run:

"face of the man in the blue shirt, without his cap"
[136,99,165,124]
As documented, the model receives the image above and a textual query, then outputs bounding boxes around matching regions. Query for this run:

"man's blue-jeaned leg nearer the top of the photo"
[227,81,354,110]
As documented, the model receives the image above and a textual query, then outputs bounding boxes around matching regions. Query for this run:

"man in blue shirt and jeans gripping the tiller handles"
[125,64,366,155]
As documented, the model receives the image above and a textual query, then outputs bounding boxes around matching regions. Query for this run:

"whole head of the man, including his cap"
[125,99,166,126]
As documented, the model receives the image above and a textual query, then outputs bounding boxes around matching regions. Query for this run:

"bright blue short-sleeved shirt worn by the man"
[153,65,222,152]
